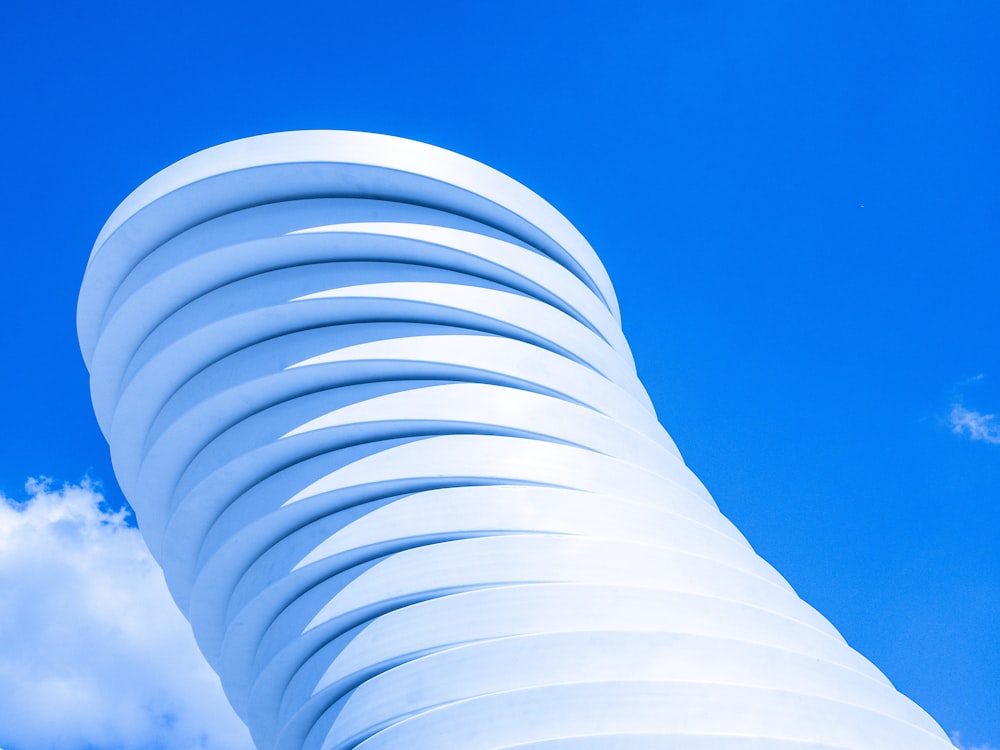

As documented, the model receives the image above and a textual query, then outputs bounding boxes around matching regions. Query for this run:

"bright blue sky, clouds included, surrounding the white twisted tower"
[0,0,1000,750]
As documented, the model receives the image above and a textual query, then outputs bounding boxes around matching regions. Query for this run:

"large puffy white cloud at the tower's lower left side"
[0,481,253,750]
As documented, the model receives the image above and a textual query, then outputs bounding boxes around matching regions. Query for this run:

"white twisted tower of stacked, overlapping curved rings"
[78,131,951,750]
